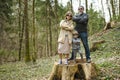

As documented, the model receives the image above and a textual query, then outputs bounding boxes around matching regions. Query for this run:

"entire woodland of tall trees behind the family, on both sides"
[0,0,120,80]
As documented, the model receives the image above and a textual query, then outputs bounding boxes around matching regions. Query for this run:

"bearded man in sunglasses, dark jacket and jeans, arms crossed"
[70,6,91,63]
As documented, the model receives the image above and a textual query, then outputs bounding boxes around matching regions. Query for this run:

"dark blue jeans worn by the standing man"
[79,32,90,60]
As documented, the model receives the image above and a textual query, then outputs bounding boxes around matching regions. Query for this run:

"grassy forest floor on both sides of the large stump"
[0,24,120,80]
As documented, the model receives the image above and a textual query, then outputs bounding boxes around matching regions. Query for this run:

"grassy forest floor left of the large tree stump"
[0,57,56,80]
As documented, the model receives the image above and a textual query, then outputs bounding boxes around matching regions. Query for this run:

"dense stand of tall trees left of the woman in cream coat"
[0,0,75,61]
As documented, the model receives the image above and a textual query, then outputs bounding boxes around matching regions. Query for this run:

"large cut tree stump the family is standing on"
[48,59,97,80]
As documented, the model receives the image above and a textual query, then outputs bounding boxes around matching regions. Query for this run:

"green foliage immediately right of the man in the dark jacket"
[88,8,104,35]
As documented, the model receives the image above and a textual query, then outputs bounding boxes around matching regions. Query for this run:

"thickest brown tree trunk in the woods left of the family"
[24,0,31,62]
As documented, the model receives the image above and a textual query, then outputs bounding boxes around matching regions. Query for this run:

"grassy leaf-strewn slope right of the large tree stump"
[90,25,120,80]
